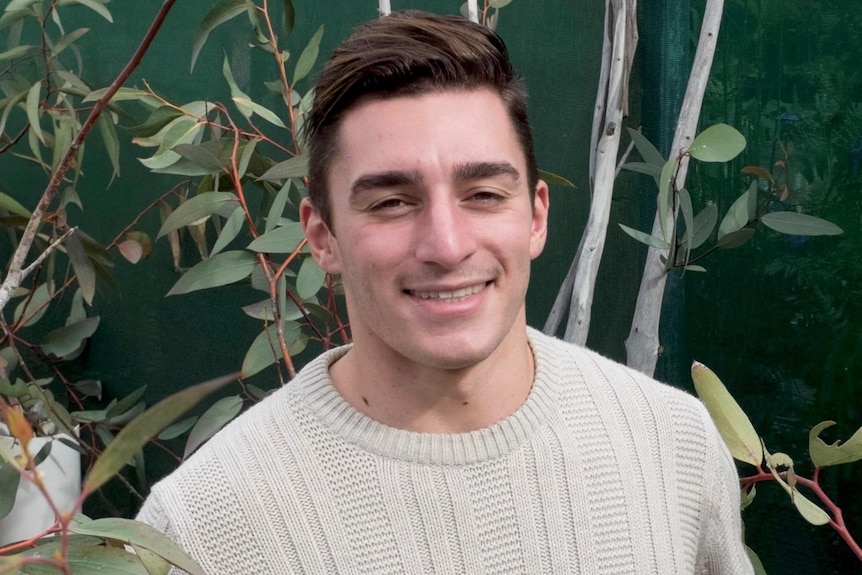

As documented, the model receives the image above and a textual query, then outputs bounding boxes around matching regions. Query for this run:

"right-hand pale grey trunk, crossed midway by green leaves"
[626,0,724,376]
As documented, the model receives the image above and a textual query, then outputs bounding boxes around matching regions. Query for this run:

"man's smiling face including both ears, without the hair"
[302,89,548,369]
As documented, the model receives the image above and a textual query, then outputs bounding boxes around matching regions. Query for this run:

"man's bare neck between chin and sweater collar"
[329,332,535,433]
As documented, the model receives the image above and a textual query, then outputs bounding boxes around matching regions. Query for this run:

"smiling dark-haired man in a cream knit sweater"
[139,12,751,575]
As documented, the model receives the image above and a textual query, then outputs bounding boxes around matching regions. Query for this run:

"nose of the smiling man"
[415,199,478,269]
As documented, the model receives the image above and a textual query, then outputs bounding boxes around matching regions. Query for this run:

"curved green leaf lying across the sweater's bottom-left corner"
[69,517,205,575]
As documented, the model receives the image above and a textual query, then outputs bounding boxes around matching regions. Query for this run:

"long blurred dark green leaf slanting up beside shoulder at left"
[84,374,236,494]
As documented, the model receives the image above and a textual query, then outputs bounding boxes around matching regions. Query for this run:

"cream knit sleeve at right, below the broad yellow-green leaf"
[698,408,754,575]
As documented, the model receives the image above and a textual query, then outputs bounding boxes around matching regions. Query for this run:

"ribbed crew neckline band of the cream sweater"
[294,328,559,465]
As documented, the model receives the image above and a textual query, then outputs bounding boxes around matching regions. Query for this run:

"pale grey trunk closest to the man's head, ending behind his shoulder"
[544,0,638,344]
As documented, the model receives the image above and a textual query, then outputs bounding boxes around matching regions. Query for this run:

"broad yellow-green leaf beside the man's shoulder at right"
[691,361,763,465]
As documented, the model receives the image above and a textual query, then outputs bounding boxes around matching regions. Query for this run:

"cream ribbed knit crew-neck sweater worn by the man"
[138,330,753,575]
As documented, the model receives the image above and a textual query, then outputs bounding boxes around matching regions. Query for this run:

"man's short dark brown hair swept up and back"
[305,10,538,230]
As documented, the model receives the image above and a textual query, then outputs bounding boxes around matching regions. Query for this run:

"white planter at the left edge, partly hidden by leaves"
[0,435,81,546]
